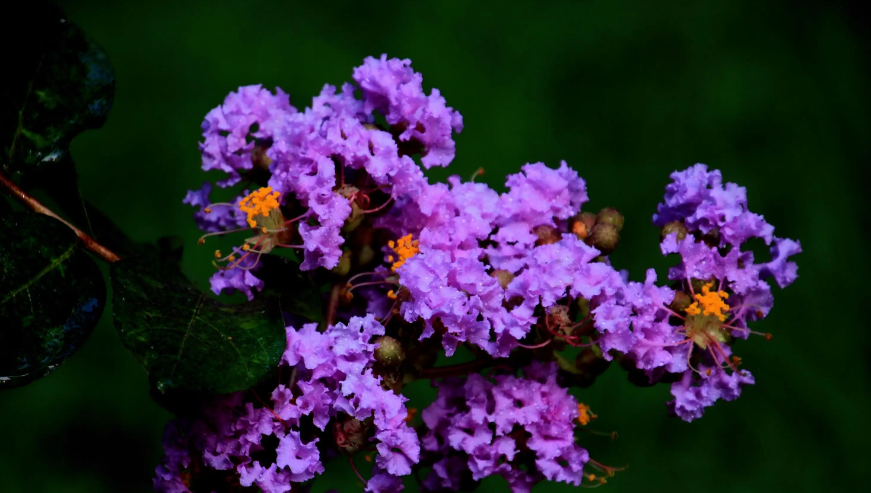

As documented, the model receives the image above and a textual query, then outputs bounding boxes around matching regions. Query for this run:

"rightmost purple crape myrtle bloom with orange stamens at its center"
[625,164,801,421]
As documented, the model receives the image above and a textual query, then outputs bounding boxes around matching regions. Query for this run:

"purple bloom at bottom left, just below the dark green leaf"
[155,315,420,493]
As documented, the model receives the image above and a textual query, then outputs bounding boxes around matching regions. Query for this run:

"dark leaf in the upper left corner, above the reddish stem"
[0,2,115,172]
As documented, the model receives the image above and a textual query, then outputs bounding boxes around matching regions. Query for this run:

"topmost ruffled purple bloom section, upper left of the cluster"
[186,55,462,276]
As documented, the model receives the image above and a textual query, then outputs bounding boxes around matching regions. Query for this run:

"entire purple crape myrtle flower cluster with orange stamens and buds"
[155,55,801,492]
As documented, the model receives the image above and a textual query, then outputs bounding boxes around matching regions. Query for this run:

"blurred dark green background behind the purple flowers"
[0,0,871,493]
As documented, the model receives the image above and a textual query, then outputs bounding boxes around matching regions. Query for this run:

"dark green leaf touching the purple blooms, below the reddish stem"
[110,257,286,393]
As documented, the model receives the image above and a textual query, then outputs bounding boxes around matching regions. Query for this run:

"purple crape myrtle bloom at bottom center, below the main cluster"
[421,362,613,492]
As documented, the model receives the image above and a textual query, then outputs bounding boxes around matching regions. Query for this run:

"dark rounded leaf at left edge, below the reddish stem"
[0,212,106,388]
